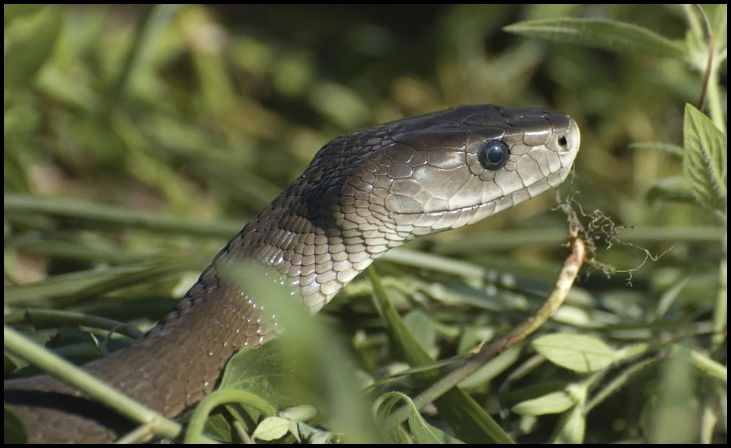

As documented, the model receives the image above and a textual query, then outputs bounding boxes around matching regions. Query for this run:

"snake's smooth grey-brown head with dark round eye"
[338,105,580,239]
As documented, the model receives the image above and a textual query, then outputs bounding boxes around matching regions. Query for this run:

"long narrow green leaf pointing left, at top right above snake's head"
[503,18,686,58]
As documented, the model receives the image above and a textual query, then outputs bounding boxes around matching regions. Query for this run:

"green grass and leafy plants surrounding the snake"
[4,5,727,443]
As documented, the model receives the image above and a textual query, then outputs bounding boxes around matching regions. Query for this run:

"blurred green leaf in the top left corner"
[3,5,63,89]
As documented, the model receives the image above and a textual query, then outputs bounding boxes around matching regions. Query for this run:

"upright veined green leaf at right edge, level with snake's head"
[683,103,727,211]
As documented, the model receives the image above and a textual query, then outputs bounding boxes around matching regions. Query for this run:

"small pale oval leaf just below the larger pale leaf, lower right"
[533,334,616,373]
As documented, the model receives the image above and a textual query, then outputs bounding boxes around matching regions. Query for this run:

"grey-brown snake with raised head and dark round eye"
[4,105,580,443]
